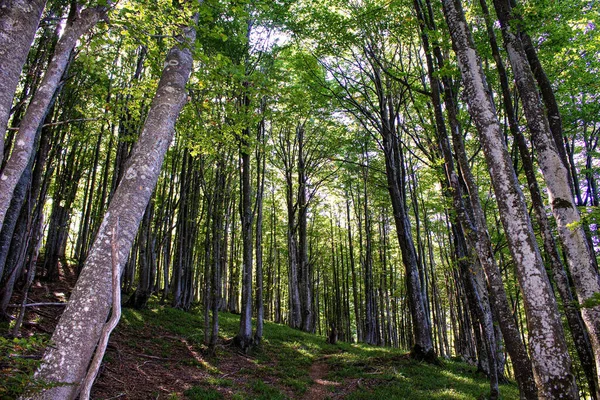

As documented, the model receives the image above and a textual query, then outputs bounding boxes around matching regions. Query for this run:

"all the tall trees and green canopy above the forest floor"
[0,0,600,398]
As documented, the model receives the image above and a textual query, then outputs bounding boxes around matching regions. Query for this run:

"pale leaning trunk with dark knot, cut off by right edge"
[494,0,600,388]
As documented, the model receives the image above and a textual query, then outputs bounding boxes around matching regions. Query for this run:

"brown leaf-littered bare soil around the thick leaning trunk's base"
[11,275,360,400]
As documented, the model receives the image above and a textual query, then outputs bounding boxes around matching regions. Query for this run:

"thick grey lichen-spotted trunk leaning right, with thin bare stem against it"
[26,14,196,400]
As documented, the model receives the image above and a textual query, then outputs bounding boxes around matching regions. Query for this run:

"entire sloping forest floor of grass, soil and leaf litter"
[0,276,519,400]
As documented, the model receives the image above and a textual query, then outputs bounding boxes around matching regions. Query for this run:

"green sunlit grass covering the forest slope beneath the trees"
[115,305,519,400]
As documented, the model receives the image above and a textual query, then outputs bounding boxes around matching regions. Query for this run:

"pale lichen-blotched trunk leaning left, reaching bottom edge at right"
[443,0,577,399]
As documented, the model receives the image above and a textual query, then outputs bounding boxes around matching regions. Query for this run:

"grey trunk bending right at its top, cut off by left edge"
[0,7,106,233]
